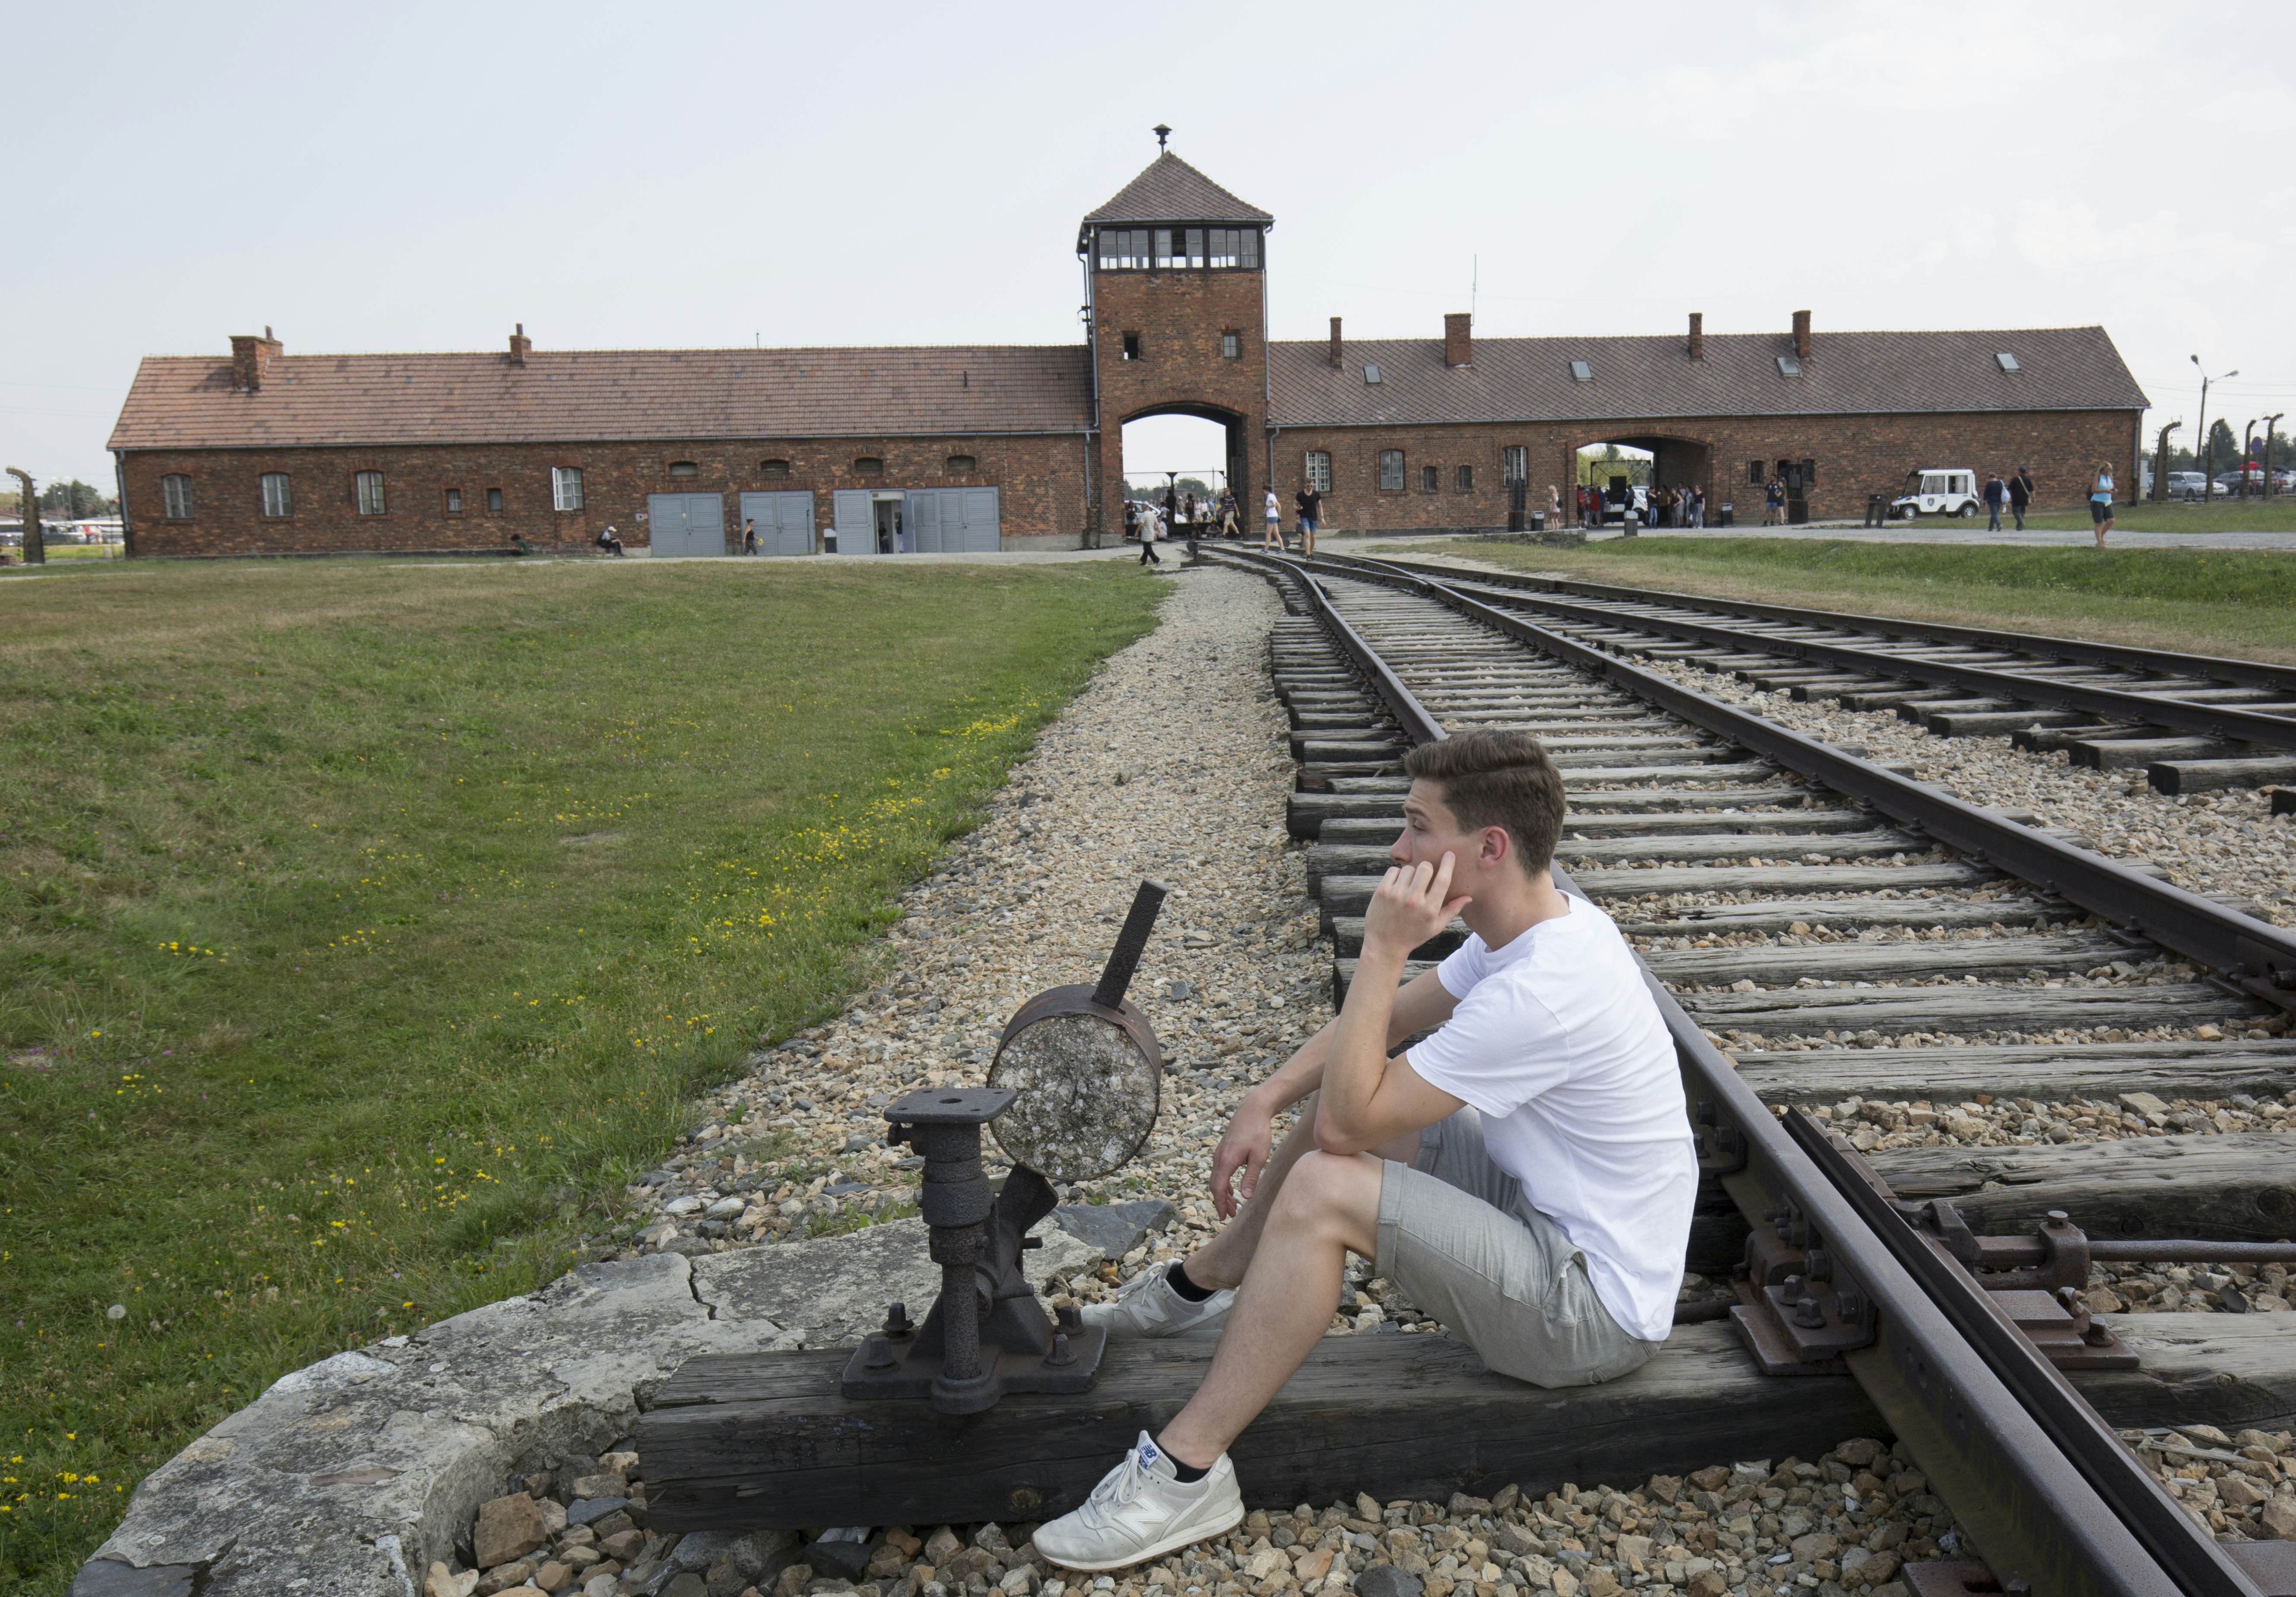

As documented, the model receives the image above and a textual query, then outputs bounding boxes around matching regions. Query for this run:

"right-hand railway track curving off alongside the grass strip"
[1325,556,2296,807]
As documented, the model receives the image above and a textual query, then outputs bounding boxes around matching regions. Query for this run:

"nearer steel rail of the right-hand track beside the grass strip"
[1304,556,2296,749]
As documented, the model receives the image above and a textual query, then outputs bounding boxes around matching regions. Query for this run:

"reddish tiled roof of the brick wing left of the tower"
[110,345,1093,448]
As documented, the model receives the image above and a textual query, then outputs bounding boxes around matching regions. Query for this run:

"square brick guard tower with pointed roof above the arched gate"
[1077,129,1274,531]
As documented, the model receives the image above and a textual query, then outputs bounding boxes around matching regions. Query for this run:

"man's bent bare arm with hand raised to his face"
[1315,855,1467,1154]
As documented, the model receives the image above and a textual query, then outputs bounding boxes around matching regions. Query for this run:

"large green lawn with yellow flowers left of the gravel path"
[0,561,1157,1592]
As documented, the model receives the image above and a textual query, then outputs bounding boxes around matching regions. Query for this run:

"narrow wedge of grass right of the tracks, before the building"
[1366,535,2296,662]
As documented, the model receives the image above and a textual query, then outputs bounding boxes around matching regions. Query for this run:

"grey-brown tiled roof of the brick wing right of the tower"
[1267,326,2147,427]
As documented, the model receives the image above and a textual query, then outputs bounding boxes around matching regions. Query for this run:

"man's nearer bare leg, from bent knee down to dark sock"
[1157,1135,1378,1468]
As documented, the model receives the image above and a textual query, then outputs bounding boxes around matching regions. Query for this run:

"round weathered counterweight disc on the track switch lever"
[990,986,1164,1181]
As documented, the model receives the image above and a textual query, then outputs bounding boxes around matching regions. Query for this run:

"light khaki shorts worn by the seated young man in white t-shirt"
[1373,1110,1660,1386]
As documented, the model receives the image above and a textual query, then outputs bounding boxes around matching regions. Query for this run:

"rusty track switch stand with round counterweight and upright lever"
[838,882,1164,1413]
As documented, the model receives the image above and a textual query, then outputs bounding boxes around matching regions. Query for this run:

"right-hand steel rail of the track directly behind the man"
[1304,561,2296,1011]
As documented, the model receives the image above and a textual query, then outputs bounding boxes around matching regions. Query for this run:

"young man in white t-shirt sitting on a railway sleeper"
[1035,731,1697,1569]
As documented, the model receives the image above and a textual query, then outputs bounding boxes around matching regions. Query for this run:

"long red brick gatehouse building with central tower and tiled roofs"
[110,154,2147,556]
